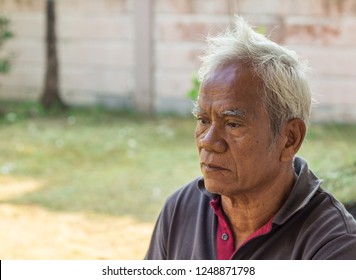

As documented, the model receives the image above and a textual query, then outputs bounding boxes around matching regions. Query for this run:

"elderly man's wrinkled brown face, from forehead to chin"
[195,63,281,196]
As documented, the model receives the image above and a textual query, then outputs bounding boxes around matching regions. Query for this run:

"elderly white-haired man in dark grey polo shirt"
[146,18,356,259]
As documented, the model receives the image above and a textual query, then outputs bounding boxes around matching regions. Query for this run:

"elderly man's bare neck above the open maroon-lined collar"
[221,171,295,247]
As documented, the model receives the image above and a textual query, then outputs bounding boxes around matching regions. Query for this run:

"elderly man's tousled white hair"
[199,17,311,139]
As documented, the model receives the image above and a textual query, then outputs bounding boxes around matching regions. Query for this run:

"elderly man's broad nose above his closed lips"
[198,125,227,153]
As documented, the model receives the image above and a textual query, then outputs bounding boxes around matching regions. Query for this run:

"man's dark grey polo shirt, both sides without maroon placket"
[145,157,356,260]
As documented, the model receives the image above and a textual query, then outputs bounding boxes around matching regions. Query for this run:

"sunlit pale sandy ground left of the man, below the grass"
[0,177,154,260]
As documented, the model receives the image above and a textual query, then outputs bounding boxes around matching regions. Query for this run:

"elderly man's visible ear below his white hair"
[280,119,307,162]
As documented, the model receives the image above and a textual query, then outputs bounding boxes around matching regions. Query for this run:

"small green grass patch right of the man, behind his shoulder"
[299,124,356,203]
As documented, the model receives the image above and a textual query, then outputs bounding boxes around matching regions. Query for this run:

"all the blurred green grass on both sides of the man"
[0,100,356,221]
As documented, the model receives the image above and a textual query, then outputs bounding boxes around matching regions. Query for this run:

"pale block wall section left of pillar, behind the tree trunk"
[0,0,134,106]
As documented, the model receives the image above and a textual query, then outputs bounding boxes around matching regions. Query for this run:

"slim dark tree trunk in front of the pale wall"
[41,0,66,110]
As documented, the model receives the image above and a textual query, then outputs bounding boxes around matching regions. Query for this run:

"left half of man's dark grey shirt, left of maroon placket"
[146,177,215,260]
